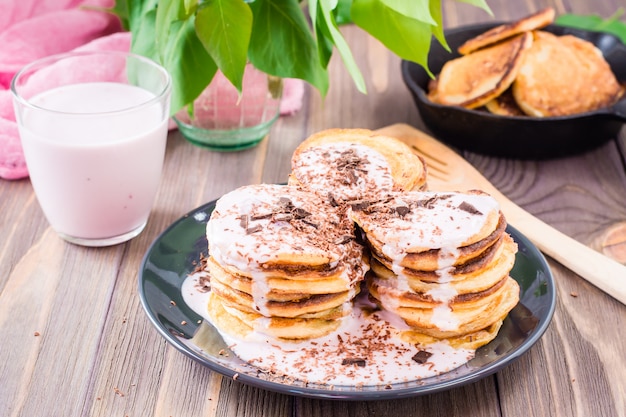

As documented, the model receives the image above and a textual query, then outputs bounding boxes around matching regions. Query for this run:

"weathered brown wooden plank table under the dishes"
[0,0,626,417]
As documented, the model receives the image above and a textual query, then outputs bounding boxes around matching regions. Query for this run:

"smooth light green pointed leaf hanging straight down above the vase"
[195,0,252,92]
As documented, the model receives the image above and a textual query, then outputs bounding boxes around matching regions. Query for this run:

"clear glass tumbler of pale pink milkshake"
[11,52,171,246]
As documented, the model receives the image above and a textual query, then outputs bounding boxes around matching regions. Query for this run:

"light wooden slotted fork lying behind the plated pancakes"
[377,124,626,304]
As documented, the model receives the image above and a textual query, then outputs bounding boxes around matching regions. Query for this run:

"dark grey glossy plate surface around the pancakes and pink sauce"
[139,201,556,401]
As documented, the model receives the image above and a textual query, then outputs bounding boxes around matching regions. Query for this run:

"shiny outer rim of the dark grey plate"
[137,199,557,401]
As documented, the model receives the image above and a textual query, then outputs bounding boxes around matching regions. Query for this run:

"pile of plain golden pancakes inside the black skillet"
[429,8,624,117]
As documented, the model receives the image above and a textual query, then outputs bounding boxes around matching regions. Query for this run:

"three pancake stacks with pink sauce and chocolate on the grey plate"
[207,129,519,349]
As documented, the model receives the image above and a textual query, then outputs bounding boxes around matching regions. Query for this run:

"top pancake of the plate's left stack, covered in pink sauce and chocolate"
[207,184,364,272]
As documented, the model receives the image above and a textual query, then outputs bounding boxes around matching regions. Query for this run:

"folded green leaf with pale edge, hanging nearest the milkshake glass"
[161,17,217,114]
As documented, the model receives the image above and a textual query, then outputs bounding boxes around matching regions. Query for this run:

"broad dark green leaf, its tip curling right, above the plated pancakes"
[248,0,328,96]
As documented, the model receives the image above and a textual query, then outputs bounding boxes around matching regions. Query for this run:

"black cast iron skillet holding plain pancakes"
[402,23,626,159]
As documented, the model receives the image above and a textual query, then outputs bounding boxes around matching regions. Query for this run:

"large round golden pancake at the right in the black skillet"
[512,32,623,117]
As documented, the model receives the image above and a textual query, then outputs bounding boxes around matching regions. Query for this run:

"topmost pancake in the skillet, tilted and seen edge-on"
[457,7,555,55]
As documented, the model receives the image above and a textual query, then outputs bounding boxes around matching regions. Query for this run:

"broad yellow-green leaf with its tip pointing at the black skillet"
[351,0,432,76]
